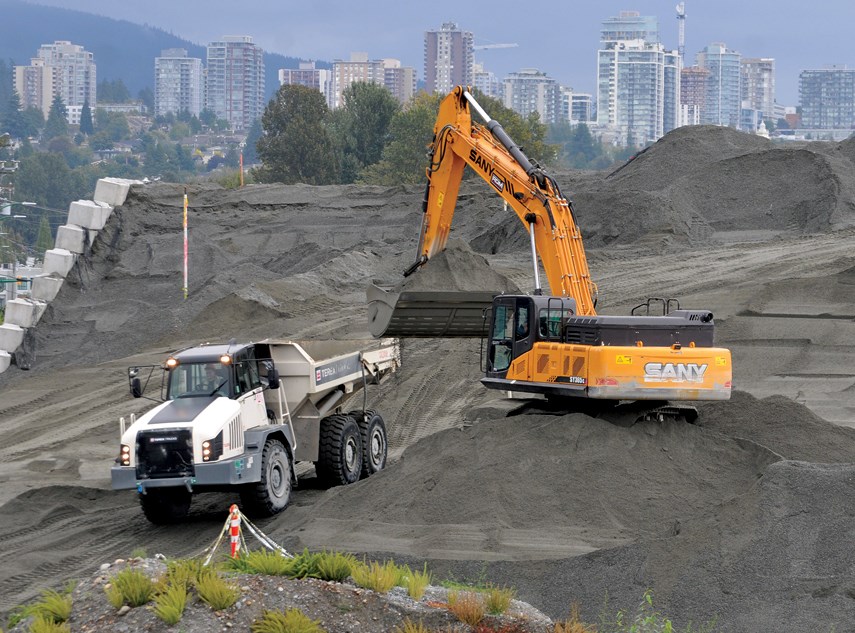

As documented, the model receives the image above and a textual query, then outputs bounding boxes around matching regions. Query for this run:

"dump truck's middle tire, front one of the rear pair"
[315,414,362,486]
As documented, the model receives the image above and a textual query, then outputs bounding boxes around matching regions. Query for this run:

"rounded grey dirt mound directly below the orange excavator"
[272,414,779,559]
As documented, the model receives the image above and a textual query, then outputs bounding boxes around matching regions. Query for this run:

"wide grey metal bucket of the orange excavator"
[367,284,494,338]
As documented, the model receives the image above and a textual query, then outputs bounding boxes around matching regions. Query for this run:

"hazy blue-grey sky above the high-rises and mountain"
[25,0,855,105]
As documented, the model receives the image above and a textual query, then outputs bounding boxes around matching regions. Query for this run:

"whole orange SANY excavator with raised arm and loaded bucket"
[367,86,732,421]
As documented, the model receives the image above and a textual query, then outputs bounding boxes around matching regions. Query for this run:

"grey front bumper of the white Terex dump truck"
[110,455,261,493]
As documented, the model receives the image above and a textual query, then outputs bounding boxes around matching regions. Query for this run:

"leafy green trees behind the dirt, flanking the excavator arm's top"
[252,83,637,185]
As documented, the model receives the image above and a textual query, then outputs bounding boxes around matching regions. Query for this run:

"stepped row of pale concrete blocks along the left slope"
[0,178,142,374]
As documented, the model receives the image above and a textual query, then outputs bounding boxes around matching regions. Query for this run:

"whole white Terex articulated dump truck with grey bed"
[111,339,401,523]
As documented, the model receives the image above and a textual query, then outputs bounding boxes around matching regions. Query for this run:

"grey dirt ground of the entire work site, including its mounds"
[0,128,855,631]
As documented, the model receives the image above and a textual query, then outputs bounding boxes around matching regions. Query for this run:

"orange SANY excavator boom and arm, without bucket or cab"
[412,86,597,316]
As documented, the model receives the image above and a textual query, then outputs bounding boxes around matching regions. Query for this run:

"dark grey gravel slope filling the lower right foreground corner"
[504,461,855,633]
